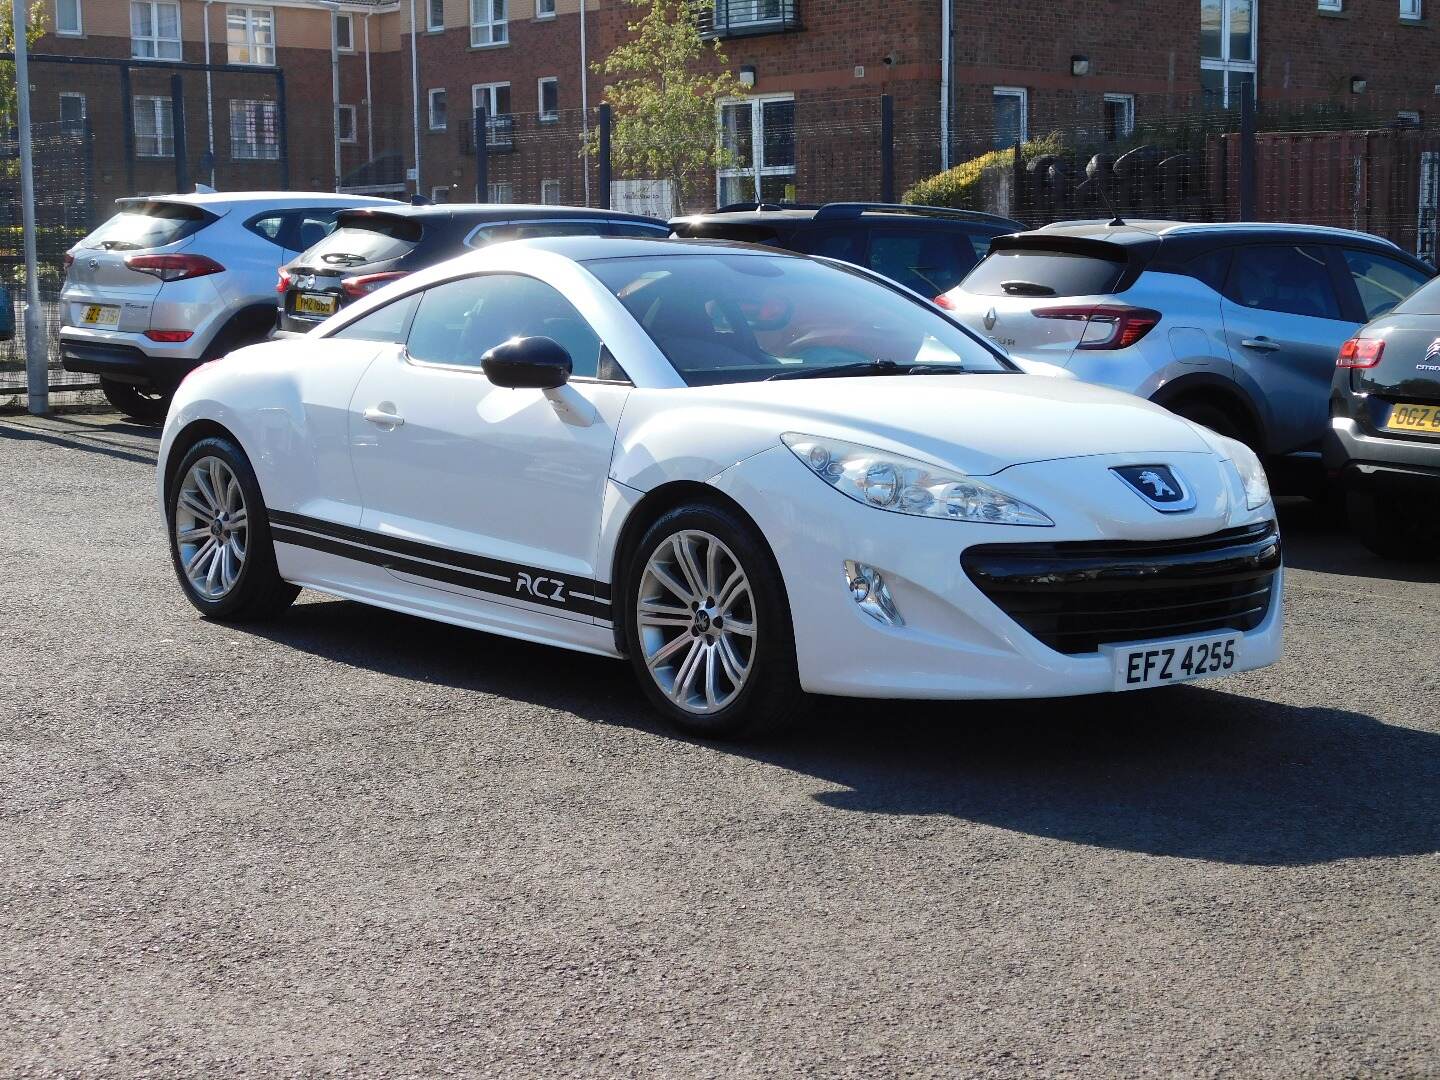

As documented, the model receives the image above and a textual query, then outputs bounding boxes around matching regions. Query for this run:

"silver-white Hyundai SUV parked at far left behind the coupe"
[60,192,395,420]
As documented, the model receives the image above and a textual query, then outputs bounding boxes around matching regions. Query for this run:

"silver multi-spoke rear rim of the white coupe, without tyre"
[174,456,249,600]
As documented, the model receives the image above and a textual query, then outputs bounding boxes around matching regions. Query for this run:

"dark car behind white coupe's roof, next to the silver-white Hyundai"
[275,203,670,334]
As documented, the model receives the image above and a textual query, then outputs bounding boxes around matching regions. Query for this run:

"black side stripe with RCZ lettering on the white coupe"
[268,510,611,619]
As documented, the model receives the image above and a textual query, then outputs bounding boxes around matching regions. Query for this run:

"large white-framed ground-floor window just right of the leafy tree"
[716,94,795,206]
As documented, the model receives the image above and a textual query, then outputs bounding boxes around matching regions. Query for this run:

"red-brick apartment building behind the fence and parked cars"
[32,0,1440,217]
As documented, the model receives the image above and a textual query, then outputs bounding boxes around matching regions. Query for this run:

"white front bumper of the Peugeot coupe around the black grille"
[711,448,1283,698]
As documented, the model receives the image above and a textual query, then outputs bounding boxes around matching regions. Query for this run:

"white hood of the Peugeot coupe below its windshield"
[621,374,1214,486]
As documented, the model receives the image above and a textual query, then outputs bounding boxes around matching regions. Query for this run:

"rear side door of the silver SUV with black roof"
[1220,243,1358,454]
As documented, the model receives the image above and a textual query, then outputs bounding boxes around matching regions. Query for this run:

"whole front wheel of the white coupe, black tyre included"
[621,503,805,739]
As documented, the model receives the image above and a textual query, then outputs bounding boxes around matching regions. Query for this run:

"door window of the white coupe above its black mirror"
[406,274,600,379]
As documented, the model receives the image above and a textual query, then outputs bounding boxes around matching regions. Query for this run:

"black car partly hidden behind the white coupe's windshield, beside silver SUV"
[670,203,1025,300]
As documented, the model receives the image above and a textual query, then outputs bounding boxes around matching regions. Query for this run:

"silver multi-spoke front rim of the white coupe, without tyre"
[635,530,756,714]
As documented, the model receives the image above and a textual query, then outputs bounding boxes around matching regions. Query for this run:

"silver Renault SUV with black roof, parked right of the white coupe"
[939,220,1434,458]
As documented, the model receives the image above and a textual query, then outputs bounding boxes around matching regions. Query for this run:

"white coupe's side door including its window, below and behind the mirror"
[350,274,629,622]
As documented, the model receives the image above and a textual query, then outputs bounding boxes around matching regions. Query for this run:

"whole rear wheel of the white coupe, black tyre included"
[166,438,300,622]
